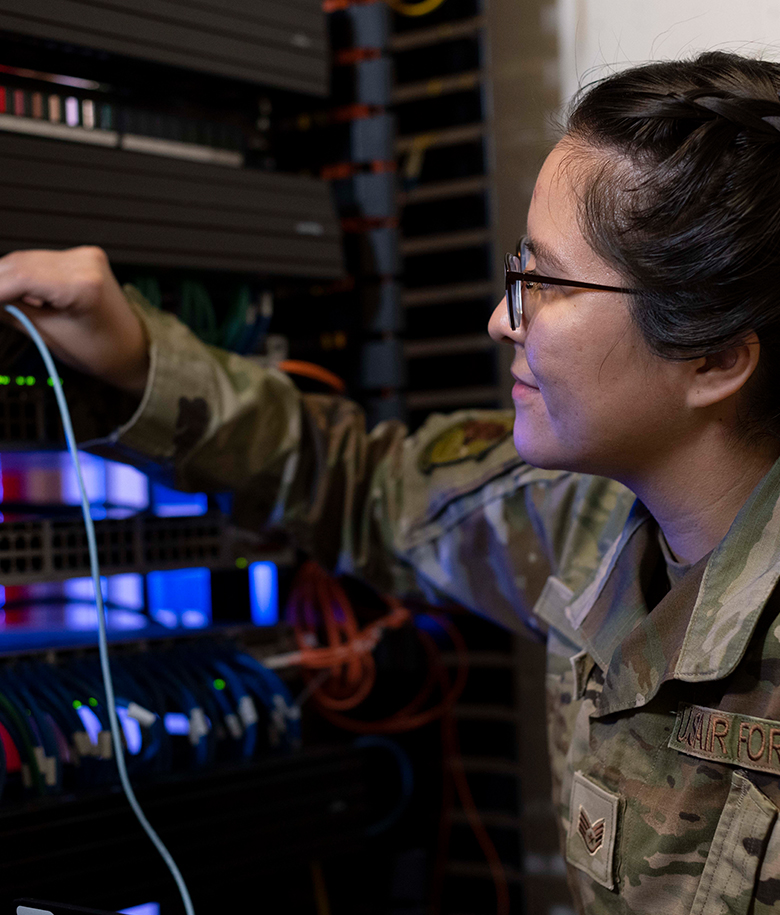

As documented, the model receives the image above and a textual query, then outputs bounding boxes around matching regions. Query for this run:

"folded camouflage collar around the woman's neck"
[566,461,780,715]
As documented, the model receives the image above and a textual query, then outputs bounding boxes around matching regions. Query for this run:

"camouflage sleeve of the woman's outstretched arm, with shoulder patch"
[93,291,632,628]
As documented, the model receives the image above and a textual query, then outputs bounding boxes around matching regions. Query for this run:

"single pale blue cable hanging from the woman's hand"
[5,305,195,915]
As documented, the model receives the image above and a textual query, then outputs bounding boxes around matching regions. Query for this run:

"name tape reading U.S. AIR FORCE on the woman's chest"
[669,702,780,775]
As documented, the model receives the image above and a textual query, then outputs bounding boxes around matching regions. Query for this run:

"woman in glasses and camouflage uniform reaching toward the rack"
[0,53,780,915]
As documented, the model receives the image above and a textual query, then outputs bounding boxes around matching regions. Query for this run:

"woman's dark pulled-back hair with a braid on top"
[567,52,780,439]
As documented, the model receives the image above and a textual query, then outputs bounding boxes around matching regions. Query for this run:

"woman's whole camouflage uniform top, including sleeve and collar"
[97,294,780,915]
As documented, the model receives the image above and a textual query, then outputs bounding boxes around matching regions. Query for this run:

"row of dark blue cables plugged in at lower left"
[0,644,300,794]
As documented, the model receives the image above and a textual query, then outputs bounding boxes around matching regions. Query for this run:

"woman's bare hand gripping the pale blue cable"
[0,247,149,394]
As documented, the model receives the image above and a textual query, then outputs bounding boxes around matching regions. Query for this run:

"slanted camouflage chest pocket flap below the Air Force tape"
[690,772,777,915]
